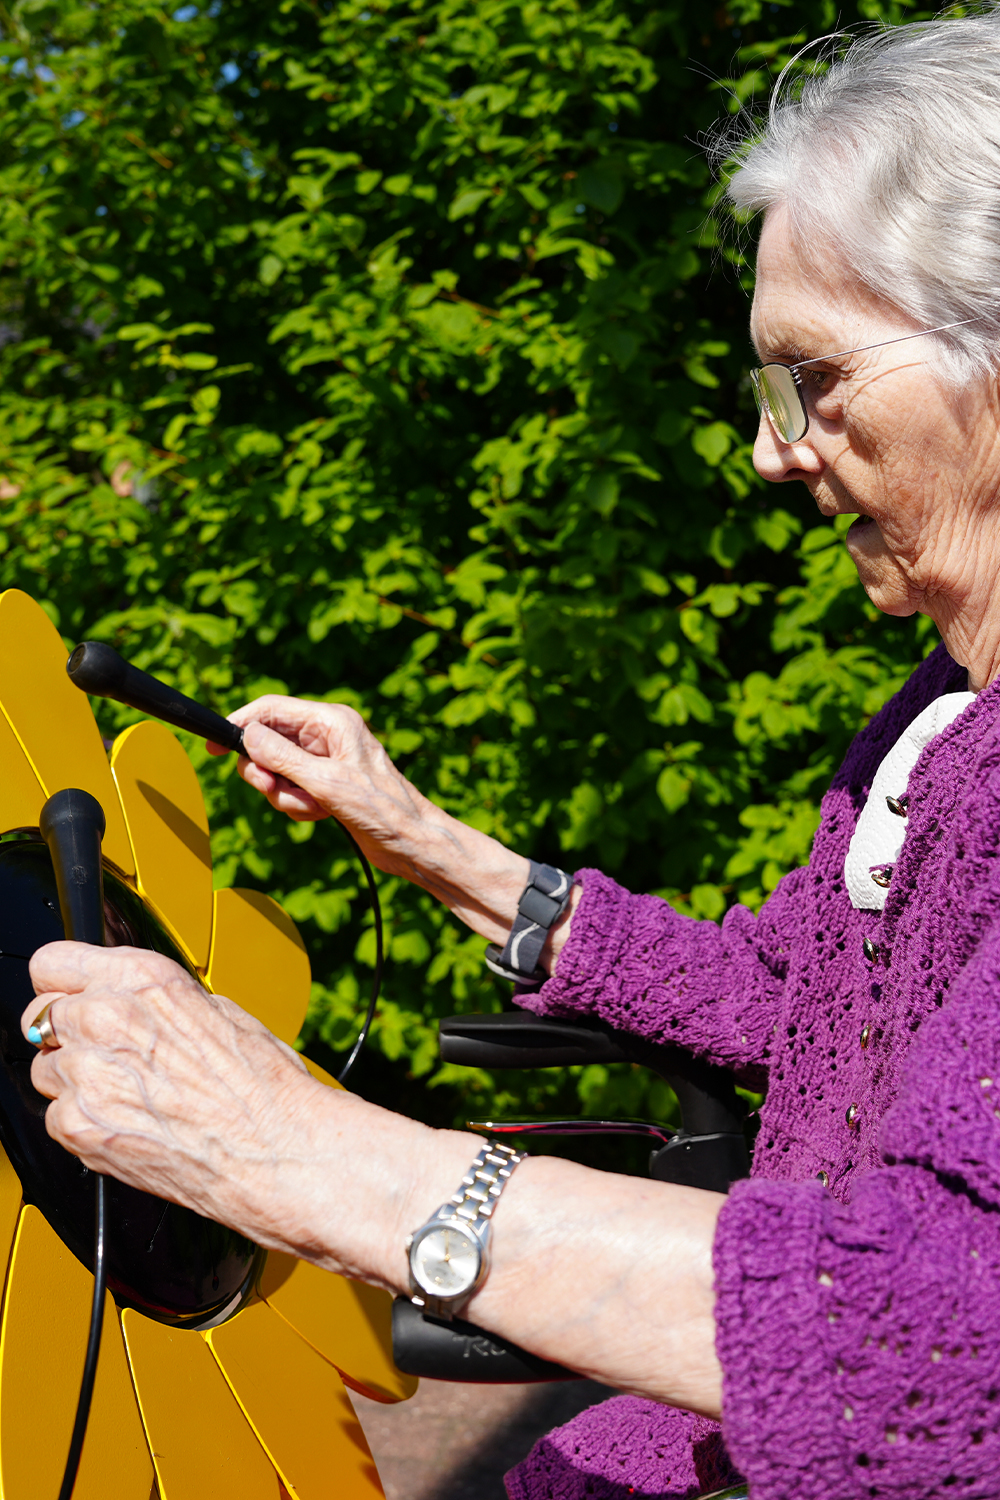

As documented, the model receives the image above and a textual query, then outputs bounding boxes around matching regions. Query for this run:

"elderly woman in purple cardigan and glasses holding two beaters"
[24,11,1000,1500]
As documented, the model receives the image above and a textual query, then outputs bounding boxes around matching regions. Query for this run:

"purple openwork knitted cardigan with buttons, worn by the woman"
[507,647,1000,1500]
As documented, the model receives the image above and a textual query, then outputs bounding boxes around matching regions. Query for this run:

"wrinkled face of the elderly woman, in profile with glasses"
[753,210,1000,624]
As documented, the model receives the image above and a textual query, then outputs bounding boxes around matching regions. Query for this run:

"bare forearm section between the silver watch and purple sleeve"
[464,1157,726,1418]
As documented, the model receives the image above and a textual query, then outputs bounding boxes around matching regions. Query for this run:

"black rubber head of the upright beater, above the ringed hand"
[39,786,105,948]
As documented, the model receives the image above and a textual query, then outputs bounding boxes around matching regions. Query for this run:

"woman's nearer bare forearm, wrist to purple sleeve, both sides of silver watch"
[262,1080,726,1416]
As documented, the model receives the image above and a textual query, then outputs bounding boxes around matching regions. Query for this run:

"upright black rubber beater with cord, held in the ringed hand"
[39,788,108,1500]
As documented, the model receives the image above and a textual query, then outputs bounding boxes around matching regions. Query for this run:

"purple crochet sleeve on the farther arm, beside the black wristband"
[517,870,807,1082]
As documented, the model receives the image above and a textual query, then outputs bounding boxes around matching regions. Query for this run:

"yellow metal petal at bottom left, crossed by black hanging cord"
[0,1208,153,1500]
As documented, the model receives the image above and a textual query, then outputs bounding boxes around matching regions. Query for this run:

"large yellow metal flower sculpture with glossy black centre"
[0,590,417,1500]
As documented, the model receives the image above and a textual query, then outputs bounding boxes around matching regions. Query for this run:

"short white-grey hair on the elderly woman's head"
[715,5,1000,381]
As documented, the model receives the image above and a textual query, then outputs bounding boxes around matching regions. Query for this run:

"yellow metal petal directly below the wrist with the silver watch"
[259,1250,418,1401]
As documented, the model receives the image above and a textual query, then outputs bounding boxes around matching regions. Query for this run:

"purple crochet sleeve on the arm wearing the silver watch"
[715,927,1000,1500]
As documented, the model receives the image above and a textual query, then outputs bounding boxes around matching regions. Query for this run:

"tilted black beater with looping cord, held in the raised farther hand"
[66,641,385,1083]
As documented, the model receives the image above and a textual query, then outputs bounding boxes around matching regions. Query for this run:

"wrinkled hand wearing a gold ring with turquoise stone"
[21,942,328,1248]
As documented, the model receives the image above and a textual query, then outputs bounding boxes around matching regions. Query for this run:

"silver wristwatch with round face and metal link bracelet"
[406,1142,528,1319]
